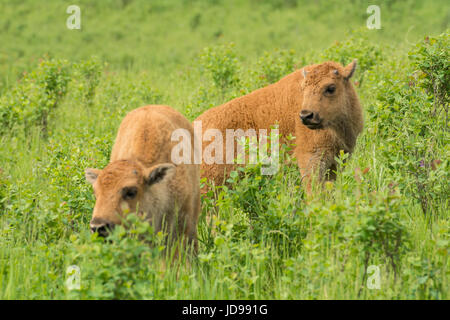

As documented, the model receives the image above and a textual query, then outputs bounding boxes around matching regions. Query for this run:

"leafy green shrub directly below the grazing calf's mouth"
[67,215,165,299]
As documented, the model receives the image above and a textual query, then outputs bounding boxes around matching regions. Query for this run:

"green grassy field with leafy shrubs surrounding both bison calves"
[0,0,450,299]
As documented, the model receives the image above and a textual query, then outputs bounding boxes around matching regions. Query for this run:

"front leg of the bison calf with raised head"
[297,152,336,195]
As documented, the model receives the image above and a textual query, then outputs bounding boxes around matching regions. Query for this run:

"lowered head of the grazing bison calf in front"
[85,160,175,236]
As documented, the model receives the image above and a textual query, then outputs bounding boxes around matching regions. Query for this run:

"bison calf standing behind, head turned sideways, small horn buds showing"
[196,61,363,189]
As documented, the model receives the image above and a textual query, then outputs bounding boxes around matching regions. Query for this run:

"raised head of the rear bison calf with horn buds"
[299,60,356,129]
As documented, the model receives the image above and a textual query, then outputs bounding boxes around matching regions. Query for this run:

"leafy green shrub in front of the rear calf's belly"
[205,136,305,254]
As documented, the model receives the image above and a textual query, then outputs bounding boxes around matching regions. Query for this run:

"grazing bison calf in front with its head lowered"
[86,105,200,250]
